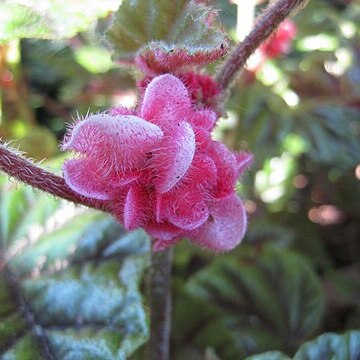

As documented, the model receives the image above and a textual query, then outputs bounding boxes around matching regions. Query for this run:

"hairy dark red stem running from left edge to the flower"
[0,144,107,211]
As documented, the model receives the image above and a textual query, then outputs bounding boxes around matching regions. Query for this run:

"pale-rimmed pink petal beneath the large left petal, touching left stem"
[63,158,139,200]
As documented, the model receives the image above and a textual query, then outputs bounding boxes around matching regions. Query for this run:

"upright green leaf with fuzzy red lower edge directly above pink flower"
[107,0,227,68]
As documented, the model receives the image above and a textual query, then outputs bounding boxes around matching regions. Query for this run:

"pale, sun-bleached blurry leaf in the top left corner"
[0,0,117,44]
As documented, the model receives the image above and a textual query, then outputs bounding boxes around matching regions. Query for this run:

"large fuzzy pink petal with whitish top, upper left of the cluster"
[63,114,163,169]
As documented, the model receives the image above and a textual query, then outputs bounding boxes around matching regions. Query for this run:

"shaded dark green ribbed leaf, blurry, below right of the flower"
[187,246,325,359]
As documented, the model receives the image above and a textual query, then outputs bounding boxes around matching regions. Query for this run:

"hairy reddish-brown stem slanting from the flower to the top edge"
[217,0,309,90]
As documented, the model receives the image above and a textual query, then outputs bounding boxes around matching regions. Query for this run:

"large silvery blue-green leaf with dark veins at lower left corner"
[0,179,149,360]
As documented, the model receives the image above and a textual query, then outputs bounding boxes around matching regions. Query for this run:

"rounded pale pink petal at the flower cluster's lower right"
[189,195,247,252]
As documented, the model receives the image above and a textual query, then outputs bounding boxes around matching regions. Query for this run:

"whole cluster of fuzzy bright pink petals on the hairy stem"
[63,74,252,251]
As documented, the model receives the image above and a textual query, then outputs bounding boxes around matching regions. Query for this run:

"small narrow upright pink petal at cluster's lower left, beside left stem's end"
[124,185,148,230]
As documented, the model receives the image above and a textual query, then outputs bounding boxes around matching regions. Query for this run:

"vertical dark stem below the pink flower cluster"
[149,248,173,360]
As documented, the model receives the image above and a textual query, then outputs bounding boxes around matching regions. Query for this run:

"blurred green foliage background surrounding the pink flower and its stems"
[0,0,360,360]
